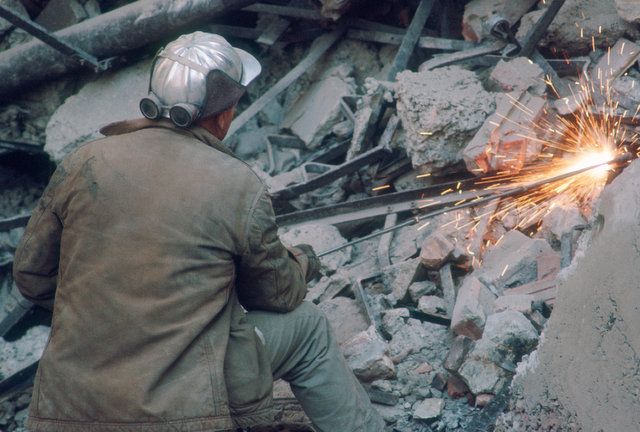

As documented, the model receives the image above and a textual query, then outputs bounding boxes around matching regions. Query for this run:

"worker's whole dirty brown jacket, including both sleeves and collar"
[13,120,306,432]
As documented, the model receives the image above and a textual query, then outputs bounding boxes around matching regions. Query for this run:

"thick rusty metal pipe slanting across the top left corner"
[0,0,255,96]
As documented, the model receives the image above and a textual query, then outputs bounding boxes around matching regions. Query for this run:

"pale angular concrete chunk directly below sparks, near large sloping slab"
[474,230,554,293]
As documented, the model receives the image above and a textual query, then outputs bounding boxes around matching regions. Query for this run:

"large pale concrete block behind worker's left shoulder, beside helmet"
[44,60,151,162]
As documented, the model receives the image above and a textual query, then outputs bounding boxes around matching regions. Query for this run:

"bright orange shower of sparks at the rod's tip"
[412,42,640,255]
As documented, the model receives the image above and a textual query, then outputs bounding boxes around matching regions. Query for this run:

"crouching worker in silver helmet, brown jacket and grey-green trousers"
[13,32,384,432]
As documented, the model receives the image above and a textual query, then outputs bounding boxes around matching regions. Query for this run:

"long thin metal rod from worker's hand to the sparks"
[317,153,632,257]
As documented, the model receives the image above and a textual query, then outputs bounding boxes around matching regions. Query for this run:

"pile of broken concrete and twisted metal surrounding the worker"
[0,0,640,432]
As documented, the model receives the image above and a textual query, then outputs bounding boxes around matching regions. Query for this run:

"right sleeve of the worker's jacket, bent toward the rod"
[236,189,307,312]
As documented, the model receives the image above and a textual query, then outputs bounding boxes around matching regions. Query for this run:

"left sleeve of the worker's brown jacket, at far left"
[13,166,65,309]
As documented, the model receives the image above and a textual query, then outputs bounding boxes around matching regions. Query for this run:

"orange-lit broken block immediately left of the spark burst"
[462,92,546,175]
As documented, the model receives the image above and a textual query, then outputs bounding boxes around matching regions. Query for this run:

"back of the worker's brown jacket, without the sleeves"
[16,121,262,430]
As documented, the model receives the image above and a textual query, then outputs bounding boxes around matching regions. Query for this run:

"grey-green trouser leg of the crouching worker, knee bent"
[246,302,384,432]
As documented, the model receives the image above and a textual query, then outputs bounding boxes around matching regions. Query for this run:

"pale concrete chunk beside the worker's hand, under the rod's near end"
[280,224,353,272]
